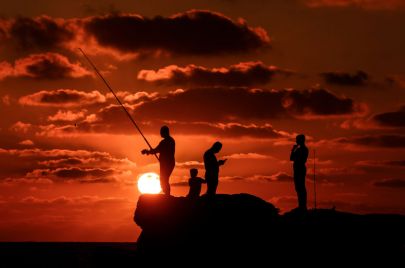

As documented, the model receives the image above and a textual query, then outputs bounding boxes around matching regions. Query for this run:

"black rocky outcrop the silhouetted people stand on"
[134,194,405,267]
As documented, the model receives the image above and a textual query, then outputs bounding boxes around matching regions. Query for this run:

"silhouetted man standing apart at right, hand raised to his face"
[290,134,308,210]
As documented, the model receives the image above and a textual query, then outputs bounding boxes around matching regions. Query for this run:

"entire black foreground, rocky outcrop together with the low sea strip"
[0,194,405,267]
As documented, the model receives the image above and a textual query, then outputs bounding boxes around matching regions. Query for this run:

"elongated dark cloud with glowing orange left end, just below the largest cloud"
[138,62,288,86]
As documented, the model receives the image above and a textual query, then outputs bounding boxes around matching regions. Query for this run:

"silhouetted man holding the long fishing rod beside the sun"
[142,126,176,195]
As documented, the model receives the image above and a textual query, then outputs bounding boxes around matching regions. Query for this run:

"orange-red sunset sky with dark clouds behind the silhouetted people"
[0,0,405,241]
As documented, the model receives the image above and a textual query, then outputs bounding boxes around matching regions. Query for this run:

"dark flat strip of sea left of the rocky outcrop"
[0,242,139,268]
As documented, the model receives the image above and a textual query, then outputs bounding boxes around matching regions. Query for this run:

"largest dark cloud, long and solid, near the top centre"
[84,10,270,55]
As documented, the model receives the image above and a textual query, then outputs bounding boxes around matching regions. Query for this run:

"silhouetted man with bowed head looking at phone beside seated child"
[204,141,226,195]
